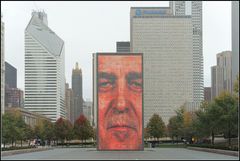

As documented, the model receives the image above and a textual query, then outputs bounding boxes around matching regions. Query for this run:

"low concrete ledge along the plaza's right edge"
[187,147,238,156]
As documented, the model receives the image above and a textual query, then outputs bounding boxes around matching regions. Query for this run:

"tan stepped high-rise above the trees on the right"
[212,51,232,99]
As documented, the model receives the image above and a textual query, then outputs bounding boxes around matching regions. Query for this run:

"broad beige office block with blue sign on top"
[130,7,193,126]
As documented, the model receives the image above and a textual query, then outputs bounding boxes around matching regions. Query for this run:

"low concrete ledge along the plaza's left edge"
[1,147,53,156]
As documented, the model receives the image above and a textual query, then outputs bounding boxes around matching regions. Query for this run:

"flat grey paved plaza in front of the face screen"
[2,148,239,160]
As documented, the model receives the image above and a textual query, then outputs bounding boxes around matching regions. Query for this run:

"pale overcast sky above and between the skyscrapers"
[1,1,231,100]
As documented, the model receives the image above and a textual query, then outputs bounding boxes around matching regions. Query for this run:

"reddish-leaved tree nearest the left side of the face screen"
[73,114,94,141]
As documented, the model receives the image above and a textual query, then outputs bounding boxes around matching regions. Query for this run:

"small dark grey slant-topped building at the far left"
[5,61,17,88]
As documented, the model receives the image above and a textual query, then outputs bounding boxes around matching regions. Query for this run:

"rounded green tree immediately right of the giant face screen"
[147,114,166,139]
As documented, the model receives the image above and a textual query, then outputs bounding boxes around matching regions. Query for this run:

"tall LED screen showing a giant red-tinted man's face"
[97,53,143,150]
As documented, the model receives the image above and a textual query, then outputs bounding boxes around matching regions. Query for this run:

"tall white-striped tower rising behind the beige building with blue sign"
[170,1,204,102]
